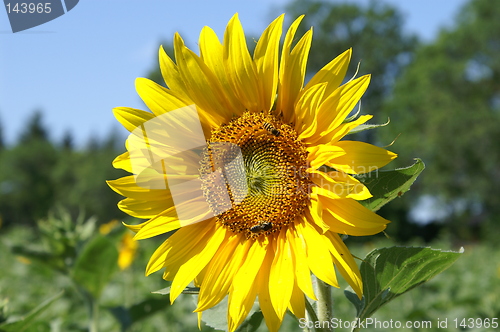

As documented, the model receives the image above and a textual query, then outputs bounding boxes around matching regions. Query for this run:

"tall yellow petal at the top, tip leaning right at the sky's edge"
[253,14,285,111]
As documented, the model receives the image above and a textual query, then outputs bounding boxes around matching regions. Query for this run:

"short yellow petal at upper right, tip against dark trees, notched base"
[304,49,352,100]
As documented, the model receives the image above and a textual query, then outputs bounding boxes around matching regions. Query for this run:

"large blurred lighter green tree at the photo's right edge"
[380,0,500,239]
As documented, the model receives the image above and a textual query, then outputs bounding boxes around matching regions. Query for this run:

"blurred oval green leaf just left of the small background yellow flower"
[72,235,118,299]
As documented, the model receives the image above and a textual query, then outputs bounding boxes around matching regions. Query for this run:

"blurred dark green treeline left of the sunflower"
[0,112,125,227]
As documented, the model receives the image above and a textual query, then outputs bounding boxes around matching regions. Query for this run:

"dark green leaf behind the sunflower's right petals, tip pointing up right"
[356,158,425,211]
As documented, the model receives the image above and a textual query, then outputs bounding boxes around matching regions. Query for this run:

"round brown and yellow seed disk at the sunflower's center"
[200,112,311,238]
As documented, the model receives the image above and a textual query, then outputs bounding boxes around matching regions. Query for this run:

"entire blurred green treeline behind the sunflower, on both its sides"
[0,0,500,243]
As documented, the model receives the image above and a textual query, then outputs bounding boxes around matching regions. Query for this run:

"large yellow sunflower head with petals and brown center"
[108,14,396,331]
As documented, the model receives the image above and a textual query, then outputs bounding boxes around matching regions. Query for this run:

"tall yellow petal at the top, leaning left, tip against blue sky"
[224,14,264,112]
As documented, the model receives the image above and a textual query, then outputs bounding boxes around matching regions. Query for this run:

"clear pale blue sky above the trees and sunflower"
[0,0,466,145]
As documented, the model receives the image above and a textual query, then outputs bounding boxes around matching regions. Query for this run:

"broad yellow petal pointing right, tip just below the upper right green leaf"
[320,196,390,236]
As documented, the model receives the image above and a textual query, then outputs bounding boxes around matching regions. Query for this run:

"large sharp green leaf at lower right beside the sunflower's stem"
[344,247,463,321]
